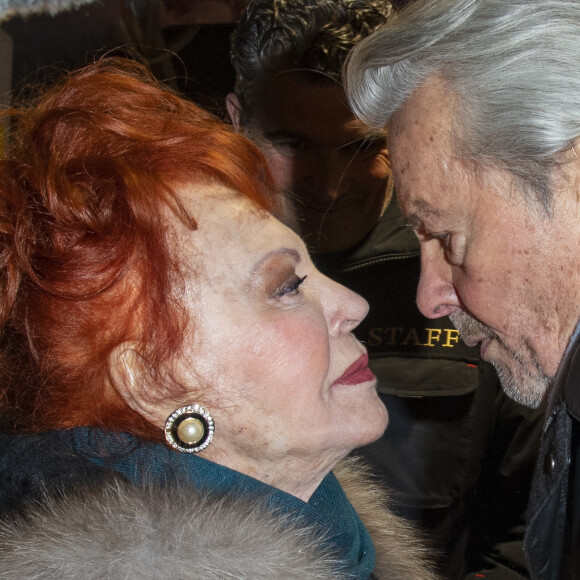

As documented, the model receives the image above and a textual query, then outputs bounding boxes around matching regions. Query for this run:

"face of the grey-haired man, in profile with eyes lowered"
[390,77,580,407]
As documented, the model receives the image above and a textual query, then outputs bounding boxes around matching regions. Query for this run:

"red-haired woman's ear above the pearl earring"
[108,342,167,427]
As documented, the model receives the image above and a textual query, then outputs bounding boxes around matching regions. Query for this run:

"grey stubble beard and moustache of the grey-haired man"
[449,311,553,409]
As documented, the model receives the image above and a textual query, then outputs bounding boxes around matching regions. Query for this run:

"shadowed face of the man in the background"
[233,73,390,253]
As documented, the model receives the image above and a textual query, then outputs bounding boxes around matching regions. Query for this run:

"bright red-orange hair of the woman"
[0,59,273,438]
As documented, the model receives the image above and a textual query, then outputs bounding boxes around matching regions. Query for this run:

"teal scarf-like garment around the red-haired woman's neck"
[60,427,375,580]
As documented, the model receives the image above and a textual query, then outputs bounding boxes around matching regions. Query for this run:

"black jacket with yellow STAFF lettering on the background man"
[314,196,543,579]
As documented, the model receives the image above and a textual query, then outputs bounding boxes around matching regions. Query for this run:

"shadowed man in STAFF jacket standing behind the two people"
[227,0,540,579]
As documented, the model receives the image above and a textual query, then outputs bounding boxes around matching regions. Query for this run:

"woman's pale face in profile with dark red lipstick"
[163,185,387,496]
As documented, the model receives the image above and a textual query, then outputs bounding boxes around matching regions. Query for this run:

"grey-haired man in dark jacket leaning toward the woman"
[346,0,580,579]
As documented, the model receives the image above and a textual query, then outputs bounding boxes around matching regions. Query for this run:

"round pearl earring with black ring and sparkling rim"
[165,405,215,453]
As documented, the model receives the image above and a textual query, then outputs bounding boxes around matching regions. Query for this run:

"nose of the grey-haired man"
[417,241,459,318]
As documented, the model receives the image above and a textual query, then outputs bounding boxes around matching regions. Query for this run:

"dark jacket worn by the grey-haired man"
[524,324,580,580]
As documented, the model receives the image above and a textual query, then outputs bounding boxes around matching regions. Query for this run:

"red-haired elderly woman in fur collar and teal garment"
[0,60,431,580]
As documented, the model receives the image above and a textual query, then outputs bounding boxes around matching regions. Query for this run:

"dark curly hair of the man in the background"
[232,0,392,113]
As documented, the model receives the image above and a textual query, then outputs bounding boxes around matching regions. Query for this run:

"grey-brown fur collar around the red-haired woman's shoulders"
[0,460,433,580]
